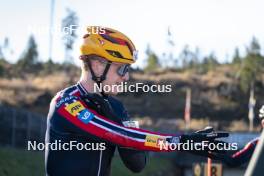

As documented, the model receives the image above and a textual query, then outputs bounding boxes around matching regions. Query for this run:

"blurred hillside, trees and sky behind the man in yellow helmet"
[0,0,264,176]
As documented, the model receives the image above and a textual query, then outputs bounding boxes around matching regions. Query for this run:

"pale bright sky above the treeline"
[0,0,264,66]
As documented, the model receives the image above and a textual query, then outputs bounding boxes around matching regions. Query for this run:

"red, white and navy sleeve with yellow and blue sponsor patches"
[55,97,180,151]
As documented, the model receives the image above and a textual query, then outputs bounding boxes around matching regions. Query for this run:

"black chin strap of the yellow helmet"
[88,60,112,98]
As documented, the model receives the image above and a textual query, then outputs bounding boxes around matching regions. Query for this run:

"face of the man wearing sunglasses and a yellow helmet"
[93,59,129,95]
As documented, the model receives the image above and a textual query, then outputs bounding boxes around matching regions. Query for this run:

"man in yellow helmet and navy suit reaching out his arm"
[45,26,228,176]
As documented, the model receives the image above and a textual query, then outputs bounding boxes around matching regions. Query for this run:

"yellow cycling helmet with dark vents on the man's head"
[80,26,137,64]
